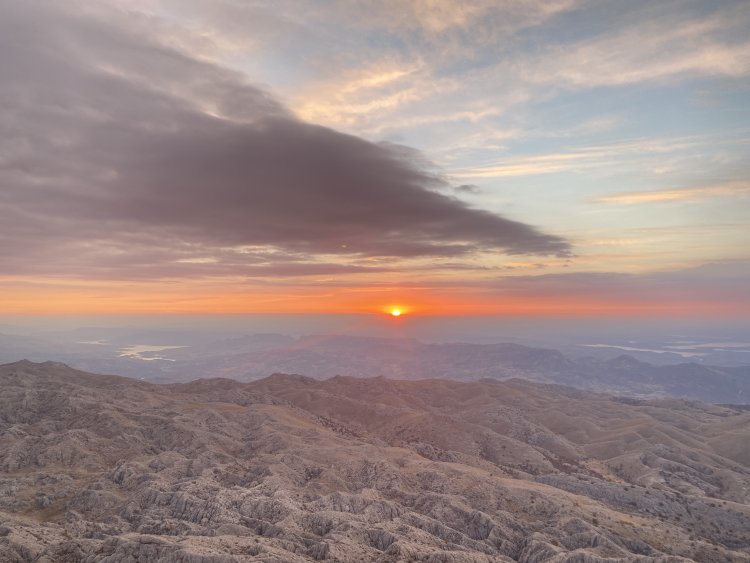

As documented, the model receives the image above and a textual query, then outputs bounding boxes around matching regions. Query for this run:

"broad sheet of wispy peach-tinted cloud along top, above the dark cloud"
[107,0,750,147]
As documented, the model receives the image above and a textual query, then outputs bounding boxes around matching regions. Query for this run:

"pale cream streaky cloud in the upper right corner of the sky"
[525,3,750,88]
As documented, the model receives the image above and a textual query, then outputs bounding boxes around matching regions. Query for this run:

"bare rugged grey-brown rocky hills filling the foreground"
[0,362,750,563]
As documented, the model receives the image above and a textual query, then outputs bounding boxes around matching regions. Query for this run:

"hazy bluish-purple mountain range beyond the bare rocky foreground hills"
[0,333,750,404]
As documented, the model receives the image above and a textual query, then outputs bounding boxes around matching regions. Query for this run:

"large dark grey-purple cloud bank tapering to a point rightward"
[0,1,569,275]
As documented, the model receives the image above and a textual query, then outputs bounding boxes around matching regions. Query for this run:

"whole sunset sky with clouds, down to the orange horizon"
[0,0,750,319]
